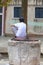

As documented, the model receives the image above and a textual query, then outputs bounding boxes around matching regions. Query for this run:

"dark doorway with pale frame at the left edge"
[0,7,4,36]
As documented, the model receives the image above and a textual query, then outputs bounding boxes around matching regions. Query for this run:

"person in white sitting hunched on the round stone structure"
[11,17,26,40]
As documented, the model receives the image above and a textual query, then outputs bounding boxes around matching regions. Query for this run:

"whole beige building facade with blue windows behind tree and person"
[0,0,43,35]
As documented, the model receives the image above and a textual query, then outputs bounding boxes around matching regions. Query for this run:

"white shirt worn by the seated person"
[13,22,26,37]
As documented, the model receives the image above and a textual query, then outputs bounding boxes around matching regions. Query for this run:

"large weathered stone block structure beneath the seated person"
[8,40,40,65]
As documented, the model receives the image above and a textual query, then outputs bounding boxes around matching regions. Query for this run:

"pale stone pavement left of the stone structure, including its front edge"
[0,36,12,52]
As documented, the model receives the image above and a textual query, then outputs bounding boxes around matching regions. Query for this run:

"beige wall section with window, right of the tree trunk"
[27,0,43,35]
